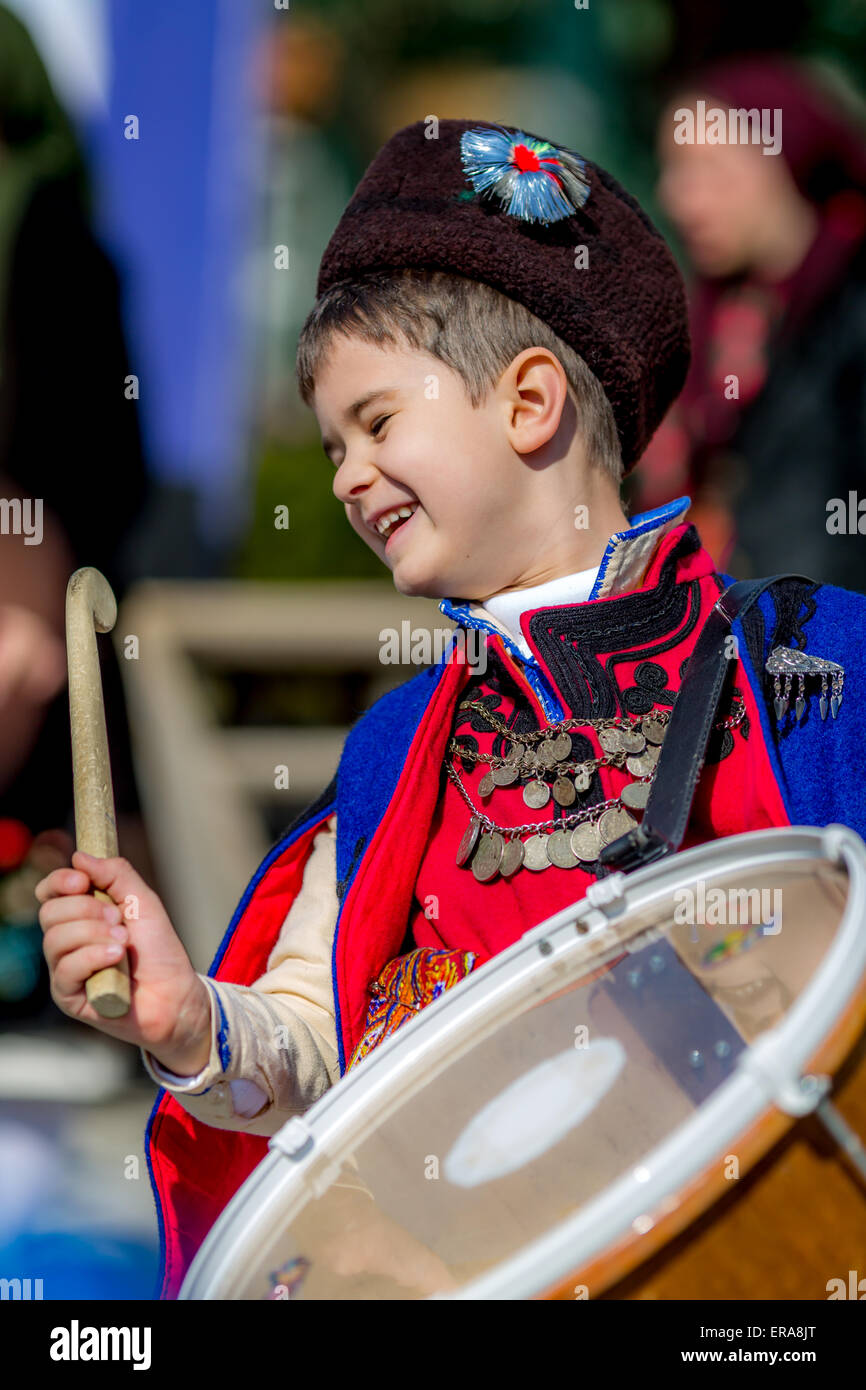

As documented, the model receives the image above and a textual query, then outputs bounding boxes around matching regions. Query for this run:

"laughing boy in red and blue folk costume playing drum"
[39,121,866,1295]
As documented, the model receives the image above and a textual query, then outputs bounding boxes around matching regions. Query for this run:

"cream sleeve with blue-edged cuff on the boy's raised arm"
[142,816,339,1134]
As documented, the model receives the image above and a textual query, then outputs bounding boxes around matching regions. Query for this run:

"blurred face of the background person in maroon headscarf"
[656,95,815,278]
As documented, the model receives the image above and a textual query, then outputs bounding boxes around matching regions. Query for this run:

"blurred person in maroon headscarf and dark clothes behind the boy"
[632,56,866,591]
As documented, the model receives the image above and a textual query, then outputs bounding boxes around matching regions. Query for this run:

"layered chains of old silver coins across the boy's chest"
[445,701,745,883]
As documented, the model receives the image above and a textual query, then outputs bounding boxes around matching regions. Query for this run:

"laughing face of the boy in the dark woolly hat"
[313,334,567,599]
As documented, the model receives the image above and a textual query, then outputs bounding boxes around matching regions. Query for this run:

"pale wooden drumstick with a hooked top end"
[67,566,129,1019]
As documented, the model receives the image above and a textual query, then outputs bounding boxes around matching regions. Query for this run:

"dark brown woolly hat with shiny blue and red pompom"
[317,120,689,471]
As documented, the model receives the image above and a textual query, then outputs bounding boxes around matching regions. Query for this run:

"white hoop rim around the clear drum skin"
[178,826,866,1300]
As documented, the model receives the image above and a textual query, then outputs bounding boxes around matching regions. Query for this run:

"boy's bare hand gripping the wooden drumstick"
[35,851,210,1076]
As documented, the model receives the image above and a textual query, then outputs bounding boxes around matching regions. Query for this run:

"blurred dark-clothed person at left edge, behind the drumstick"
[0,6,146,1022]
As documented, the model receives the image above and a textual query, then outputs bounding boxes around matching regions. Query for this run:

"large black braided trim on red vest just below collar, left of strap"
[528,525,701,719]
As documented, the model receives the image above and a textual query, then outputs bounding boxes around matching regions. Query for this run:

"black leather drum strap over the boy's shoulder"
[599,574,815,877]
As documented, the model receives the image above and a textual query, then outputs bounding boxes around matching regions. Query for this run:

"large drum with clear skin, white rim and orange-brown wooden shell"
[181,826,866,1300]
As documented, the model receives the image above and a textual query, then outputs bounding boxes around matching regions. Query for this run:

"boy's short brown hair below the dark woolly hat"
[296,268,623,485]
